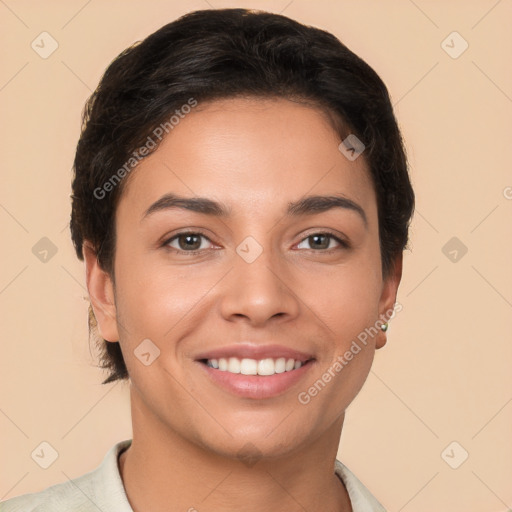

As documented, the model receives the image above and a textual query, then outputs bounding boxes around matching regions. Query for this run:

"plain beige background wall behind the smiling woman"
[0,0,512,512]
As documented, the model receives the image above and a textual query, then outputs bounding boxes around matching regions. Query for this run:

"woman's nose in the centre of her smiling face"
[220,238,300,327]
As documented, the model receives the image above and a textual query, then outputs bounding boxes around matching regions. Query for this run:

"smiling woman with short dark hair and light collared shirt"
[1,9,414,512]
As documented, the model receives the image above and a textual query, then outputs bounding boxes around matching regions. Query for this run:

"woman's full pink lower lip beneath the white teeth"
[198,360,314,400]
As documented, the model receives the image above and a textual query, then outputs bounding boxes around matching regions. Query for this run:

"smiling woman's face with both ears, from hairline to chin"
[87,99,401,456]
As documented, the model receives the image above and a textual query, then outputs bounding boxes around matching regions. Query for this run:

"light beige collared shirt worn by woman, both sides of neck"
[0,439,386,512]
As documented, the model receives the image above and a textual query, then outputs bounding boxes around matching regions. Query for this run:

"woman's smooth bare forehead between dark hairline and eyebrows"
[119,98,375,222]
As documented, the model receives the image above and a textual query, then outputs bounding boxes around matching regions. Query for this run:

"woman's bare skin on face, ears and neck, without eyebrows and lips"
[85,98,402,512]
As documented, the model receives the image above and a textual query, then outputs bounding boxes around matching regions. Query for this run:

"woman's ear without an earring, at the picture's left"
[82,241,119,341]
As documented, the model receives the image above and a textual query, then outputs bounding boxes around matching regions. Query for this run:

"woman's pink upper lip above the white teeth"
[195,343,313,363]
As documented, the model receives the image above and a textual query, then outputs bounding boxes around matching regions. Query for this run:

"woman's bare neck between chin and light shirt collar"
[119,388,352,512]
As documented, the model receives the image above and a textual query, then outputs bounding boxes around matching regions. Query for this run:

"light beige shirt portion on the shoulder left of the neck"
[0,440,131,512]
